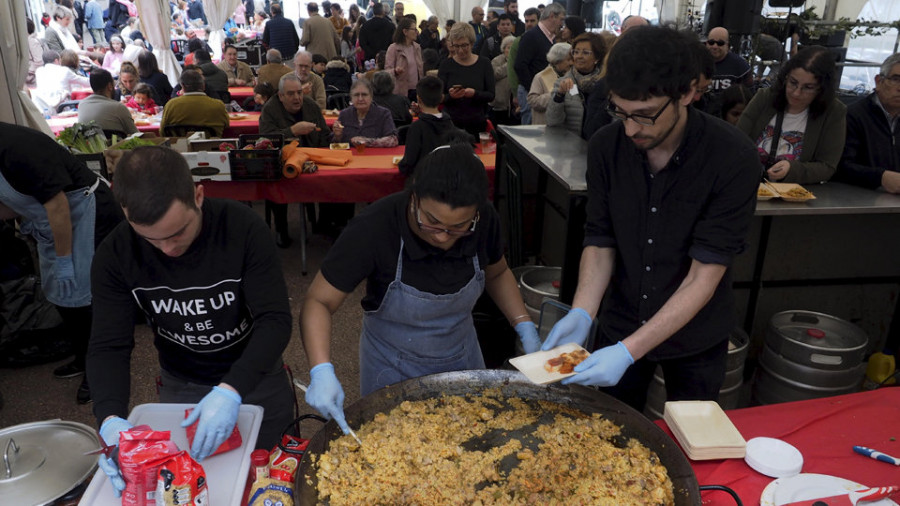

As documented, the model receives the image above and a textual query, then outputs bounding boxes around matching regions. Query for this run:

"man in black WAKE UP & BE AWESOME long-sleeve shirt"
[87,146,293,488]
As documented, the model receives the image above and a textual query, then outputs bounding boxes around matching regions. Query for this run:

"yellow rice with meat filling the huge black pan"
[312,389,674,506]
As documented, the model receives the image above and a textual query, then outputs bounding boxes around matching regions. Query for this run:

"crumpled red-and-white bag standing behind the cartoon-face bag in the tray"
[119,425,179,506]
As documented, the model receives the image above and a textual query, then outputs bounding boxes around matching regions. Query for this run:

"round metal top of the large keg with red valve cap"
[769,311,869,350]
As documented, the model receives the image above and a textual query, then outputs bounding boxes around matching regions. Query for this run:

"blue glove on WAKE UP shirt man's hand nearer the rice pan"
[181,386,241,462]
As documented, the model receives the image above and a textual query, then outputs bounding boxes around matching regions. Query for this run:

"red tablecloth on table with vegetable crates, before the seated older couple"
[202,146,495,204]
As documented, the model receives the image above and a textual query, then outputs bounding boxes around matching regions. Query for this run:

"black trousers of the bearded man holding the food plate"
[600,338,728,411]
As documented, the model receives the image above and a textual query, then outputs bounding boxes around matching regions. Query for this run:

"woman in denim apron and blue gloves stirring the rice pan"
[300,141,540,427]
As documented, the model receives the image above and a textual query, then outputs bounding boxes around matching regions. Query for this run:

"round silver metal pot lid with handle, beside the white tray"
[0,420,100,504]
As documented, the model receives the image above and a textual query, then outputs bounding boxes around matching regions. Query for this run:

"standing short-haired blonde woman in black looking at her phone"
[438,23,496,138]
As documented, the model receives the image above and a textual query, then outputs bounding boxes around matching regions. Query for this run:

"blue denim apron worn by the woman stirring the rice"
[359,239,484,396]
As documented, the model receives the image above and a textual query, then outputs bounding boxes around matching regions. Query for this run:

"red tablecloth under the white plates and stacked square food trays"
[656,387,900,506]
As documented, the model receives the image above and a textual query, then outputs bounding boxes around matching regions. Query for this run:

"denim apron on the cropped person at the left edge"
[0,173,101,307]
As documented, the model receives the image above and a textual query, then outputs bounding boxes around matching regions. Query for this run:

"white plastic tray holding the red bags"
[78,404,263,506]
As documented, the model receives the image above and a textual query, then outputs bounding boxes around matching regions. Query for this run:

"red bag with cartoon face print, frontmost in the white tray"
[156,452,209,506]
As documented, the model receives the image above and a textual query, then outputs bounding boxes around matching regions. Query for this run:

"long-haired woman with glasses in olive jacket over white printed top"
[737,46,847,184]
